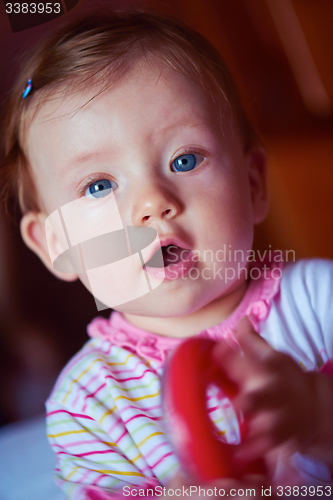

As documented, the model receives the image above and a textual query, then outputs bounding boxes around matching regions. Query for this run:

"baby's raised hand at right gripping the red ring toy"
[211,320,333,461]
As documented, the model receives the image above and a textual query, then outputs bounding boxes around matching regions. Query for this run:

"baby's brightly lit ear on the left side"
[20,212,78,281]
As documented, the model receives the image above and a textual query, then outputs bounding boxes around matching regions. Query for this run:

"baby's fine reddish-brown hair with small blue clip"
[1,11,257,213]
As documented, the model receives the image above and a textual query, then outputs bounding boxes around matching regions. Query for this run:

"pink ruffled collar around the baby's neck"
[87,262,283,365]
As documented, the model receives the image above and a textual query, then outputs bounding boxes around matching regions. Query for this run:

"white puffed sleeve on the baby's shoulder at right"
[260,259,333,370]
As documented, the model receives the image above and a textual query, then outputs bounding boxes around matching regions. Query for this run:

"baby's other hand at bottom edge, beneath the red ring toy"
[163,471,267,500]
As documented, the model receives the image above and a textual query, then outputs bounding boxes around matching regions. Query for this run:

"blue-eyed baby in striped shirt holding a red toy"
[2,7,333,499]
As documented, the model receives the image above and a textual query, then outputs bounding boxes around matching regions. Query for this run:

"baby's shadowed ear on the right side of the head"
[246,144,269,224]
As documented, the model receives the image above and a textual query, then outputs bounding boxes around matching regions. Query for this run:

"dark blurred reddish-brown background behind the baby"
[0,0,333,424]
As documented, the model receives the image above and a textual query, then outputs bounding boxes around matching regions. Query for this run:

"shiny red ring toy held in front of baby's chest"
[163,337,267,481]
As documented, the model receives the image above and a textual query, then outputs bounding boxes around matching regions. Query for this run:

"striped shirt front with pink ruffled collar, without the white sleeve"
[46,263,281,500]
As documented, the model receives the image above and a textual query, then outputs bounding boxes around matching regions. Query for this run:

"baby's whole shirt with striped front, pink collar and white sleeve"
[46,260,333,500]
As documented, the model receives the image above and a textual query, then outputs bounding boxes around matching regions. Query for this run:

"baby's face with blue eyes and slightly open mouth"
[27,68,261,317]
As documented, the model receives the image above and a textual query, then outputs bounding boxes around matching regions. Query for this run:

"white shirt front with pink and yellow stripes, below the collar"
[46,338,237,499]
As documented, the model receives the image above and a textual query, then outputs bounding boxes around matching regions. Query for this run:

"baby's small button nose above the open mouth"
[132,184,181,225]
